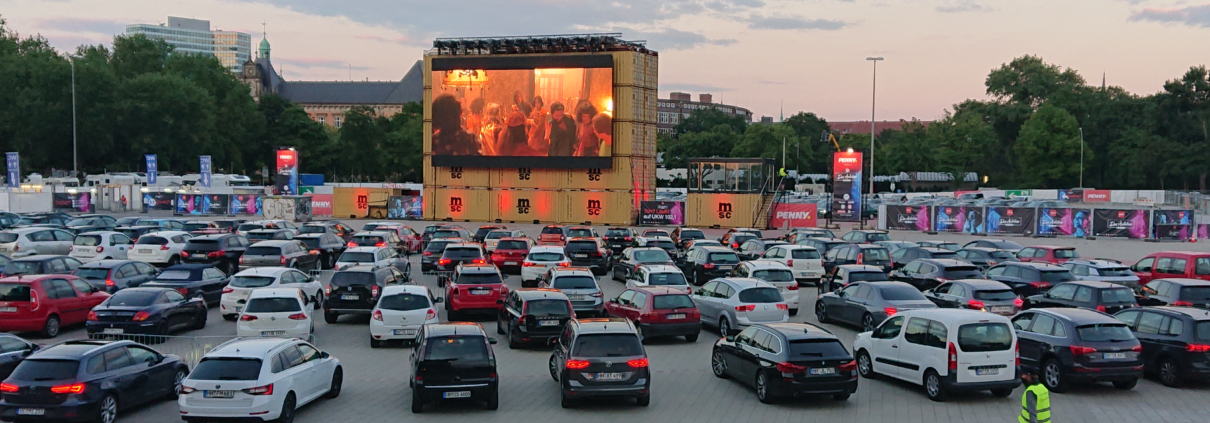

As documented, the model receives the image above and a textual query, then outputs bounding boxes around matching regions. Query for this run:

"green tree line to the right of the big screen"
[658,56,1210,191]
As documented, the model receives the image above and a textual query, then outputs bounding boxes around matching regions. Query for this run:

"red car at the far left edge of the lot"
[0,274,109,337]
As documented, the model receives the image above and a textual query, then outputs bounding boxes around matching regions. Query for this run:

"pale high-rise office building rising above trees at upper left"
[126,16,252,73]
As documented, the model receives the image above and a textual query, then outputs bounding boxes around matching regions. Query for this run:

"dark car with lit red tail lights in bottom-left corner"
[0,341,189,423]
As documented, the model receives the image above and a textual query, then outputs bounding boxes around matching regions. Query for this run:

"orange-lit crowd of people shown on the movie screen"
[433,92,613,157]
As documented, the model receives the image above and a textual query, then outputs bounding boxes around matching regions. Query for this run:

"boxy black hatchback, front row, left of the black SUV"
[408,323,500,413]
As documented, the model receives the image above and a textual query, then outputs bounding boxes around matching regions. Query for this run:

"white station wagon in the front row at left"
[177,338,344,422]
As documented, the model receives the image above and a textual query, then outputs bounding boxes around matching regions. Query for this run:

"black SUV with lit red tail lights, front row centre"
[549,319,651,408]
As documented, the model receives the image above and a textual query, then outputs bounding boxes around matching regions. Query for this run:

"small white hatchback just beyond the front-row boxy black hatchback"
[370,285,442,348]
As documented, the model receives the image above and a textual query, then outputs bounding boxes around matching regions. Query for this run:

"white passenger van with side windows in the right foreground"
[853,308,1021,401]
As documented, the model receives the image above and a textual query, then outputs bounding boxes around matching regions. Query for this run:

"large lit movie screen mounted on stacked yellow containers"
[431,54,615,169]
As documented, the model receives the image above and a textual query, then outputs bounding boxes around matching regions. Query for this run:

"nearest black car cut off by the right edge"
[1113,307,1210,388]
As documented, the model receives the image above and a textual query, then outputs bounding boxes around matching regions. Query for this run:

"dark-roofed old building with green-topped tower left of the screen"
[240,39,425,128]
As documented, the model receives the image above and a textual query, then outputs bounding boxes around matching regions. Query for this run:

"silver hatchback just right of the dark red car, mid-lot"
[691,278,790,336]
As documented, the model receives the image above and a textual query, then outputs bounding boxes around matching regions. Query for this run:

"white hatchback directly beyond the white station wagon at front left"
[235,288,315,340]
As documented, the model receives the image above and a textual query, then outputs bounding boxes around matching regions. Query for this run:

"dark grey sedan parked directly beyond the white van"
[816,282,937,332]
